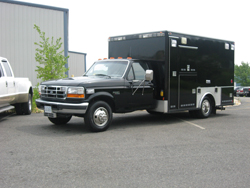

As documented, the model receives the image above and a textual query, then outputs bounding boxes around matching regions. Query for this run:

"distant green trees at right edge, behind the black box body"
[234,62,250,86]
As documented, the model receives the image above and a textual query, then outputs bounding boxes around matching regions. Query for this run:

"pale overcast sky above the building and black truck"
[20,0,250,68]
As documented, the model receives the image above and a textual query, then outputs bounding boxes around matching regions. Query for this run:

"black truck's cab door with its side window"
[126,62,154,110]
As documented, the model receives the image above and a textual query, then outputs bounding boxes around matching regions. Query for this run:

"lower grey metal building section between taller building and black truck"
[68,51,86,77]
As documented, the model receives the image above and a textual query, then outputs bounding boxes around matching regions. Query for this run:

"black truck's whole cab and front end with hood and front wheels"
[36,58,156,131]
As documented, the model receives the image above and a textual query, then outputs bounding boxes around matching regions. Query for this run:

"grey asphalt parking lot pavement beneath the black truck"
[0,97,250,188]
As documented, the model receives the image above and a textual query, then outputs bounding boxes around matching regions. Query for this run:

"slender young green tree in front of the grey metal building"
[34,24,69,81]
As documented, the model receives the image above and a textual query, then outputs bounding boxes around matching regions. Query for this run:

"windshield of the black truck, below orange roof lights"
[84,61,128,77]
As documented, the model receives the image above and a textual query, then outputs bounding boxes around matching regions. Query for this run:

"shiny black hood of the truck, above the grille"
[41,76,124,88]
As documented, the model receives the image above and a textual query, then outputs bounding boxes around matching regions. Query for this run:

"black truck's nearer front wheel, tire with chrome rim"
[84,101,113,132]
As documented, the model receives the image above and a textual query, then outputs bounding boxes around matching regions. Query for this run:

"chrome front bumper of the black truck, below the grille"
[36,99,89,115]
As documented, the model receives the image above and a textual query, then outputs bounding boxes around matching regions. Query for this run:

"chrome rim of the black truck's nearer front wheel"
[93,107,108,127]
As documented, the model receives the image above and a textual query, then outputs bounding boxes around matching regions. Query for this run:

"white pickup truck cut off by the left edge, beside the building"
[0,57,33,115]
